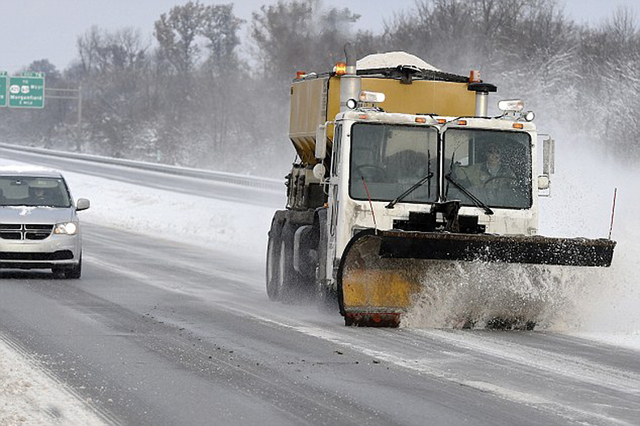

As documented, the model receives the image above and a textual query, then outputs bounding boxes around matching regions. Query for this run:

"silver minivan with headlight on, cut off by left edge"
[0,166,90,278]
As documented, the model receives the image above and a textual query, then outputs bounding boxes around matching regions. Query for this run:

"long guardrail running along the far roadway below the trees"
[0,143,285,192]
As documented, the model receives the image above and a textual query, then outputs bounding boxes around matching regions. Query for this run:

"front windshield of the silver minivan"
[0,176,71,208]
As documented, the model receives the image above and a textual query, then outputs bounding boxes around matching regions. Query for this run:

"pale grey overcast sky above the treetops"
[0,0,640,73]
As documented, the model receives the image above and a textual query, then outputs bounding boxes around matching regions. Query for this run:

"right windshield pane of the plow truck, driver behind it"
[443,129,532,209]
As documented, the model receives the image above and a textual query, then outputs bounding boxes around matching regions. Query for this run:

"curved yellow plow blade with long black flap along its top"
[337,230,616,326]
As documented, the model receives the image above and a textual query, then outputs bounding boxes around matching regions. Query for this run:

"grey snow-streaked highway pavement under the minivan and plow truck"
[0,147,640,425]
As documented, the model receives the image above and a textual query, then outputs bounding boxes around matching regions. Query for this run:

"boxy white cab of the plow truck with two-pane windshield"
[326,109,538,290]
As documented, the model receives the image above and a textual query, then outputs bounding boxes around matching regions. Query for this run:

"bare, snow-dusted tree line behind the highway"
[0,0,640,176]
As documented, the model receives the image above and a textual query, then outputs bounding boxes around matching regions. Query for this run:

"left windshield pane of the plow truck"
[349,123,438,203]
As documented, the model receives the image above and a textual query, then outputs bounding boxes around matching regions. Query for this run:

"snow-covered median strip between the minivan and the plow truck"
[64,172,274,259]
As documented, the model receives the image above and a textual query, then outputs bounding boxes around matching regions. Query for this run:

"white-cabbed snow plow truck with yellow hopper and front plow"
[266,45,615,327]
